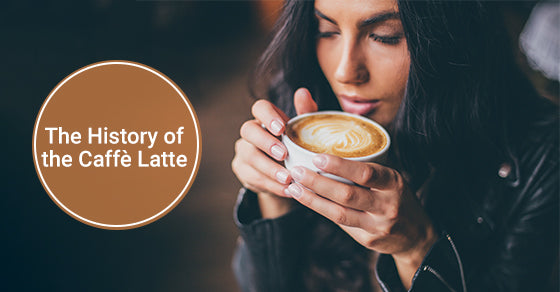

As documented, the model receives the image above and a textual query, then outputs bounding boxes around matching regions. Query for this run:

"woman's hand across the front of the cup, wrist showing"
[285,154,437,288]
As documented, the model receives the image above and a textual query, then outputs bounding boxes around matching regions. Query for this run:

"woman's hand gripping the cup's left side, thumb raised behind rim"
[231,88,317,218]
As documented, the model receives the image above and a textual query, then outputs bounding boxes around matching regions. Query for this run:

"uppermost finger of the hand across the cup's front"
[313,154,403,190]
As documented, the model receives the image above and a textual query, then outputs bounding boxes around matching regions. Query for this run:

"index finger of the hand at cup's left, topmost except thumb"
[251,99,289,136]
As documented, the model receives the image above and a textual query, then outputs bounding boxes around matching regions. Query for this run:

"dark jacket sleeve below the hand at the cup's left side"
[233,189,308,291]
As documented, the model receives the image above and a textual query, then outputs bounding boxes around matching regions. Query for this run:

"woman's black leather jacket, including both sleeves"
[233,117,560,292]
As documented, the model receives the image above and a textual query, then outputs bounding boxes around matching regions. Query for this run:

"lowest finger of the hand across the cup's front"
[285,183,365,227]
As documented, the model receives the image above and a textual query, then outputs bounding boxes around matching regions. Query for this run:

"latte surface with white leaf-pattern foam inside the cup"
[287,114,387,157]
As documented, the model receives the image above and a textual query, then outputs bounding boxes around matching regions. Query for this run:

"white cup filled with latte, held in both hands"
[282,111,390,184]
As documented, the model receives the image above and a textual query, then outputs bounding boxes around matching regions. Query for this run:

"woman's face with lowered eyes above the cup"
[315,0,410,126]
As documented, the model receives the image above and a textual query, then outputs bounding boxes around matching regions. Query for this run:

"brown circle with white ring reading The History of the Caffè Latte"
[33,61,201,229]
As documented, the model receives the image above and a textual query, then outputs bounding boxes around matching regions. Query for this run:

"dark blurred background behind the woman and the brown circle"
[0,0,557,291]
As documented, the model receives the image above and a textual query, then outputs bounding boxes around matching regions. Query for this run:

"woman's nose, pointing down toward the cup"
[334,40,369,84]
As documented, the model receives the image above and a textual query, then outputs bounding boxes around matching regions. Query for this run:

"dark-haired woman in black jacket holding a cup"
[232,0,559,291]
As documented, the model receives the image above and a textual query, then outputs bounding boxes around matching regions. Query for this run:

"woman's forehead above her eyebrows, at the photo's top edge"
[315,0,399,22]
